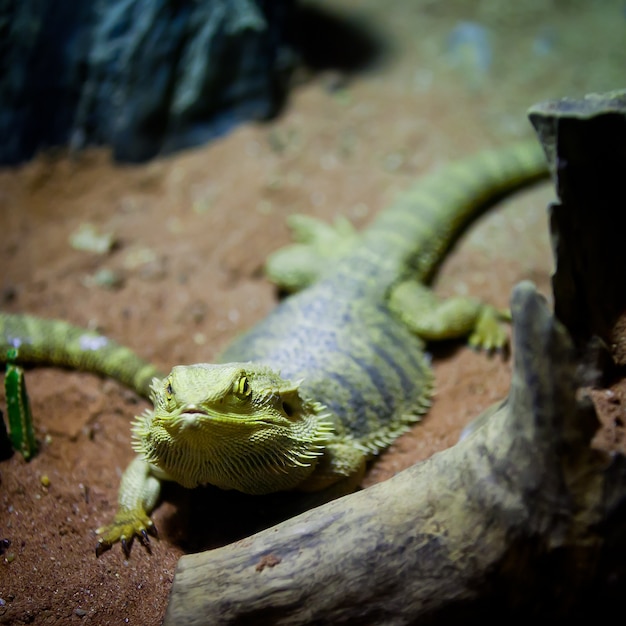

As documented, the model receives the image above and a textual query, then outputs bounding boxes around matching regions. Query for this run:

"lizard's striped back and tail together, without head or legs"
[220,142,546,452]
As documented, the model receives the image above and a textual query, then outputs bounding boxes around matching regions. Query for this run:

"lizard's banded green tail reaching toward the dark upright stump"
[364,140,548,282]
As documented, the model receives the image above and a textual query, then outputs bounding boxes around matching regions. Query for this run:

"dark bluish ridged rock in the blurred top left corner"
[0,0,295,164]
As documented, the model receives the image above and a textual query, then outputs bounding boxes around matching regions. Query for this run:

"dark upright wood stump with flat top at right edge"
[529,91,626,363]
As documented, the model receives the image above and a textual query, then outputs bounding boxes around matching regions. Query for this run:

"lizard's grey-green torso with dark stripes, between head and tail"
[220,263,432,453]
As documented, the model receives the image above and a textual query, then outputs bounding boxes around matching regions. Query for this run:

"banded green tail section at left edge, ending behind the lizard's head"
[0,313,163,398]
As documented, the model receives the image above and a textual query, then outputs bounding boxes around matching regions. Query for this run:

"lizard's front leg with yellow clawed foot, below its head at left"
[96,456,161,557]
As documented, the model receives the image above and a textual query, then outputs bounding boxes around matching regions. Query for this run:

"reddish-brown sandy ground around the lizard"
[0,0,626,624]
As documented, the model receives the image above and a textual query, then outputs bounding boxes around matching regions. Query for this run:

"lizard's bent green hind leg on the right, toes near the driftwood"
[389,280,510,351]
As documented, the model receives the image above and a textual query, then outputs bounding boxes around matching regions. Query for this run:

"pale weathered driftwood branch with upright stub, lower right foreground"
[165,90,626,625]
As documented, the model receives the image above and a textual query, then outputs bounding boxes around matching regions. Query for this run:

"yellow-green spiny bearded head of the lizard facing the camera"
[133,363,332,494]
